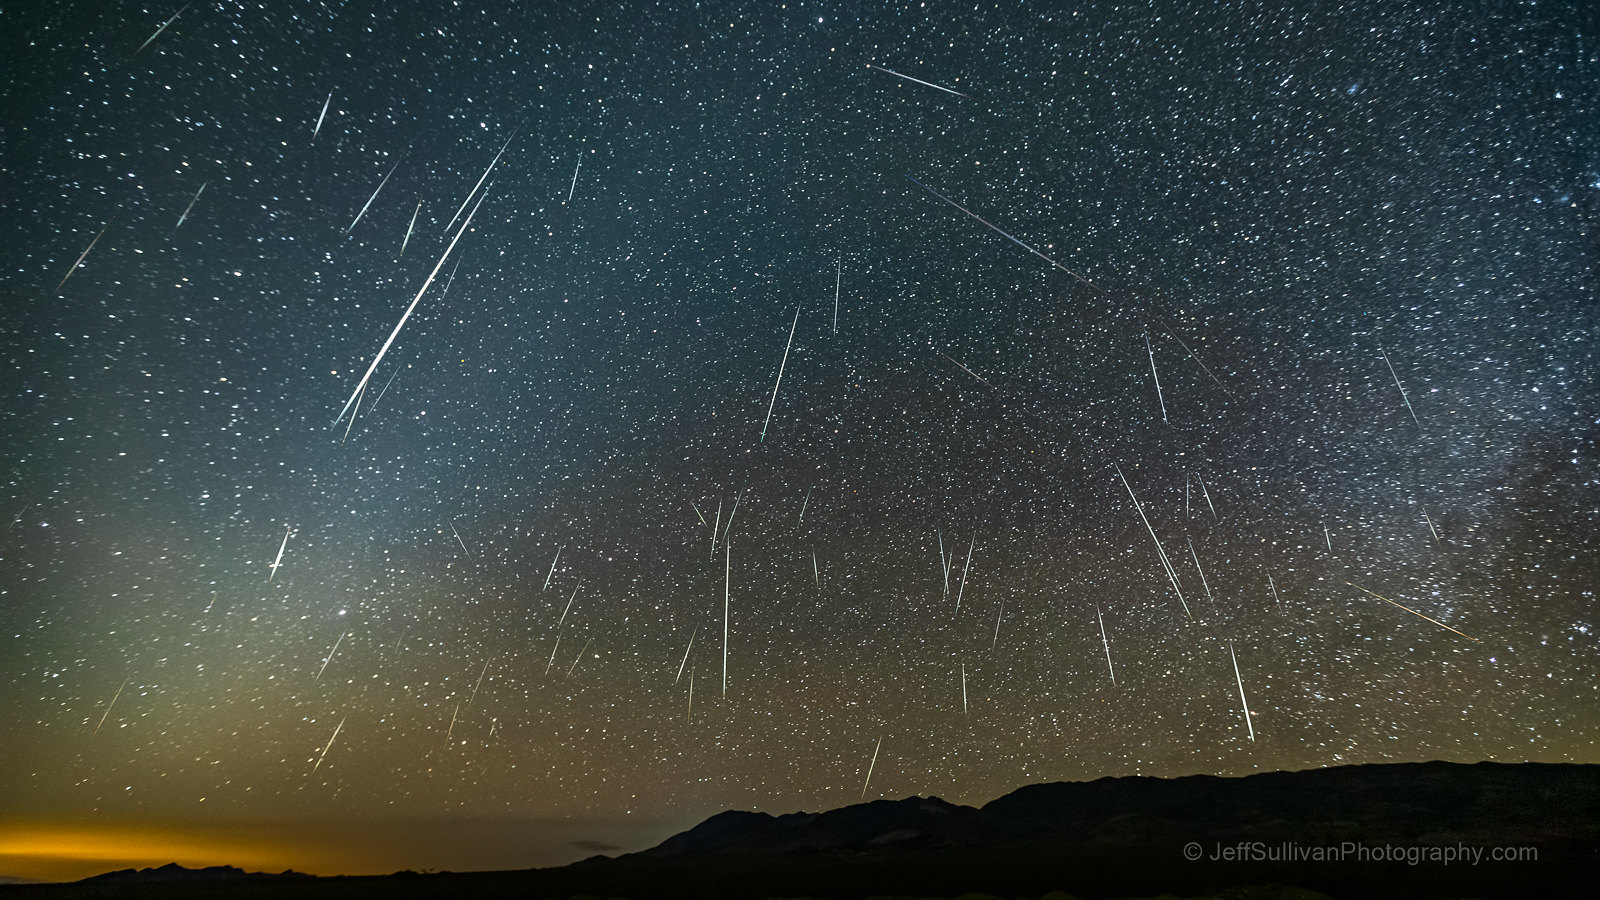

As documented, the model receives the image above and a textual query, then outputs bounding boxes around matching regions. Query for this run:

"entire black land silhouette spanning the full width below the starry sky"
[11,762,1600,900]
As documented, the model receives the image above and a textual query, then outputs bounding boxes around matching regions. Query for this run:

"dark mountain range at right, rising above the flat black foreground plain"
[617,762,1600,865]
